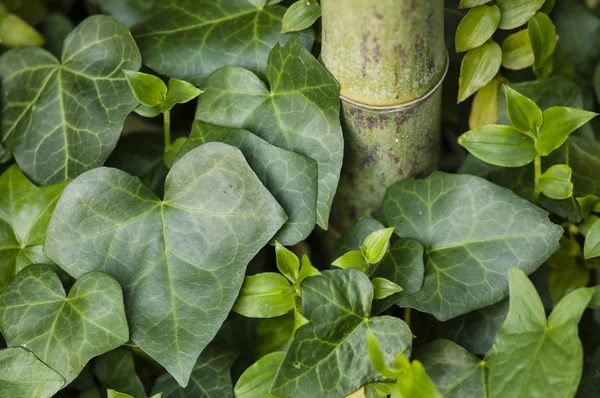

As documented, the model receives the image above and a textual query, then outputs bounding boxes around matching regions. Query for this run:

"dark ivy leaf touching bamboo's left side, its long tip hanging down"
[196,39,344,229]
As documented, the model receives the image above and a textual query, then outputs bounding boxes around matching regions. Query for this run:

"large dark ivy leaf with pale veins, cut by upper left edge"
[0,15,141,185]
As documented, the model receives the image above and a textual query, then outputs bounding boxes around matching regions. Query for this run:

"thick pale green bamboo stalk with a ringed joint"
[321,0,448,231]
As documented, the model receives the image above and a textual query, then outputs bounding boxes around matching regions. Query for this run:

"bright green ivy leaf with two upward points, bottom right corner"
[486,269,593,398]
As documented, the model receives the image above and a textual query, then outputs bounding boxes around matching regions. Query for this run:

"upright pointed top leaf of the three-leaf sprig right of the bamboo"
[502,85,543,134]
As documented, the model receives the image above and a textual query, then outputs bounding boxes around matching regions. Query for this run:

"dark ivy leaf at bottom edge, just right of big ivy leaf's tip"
[152,344,236,398]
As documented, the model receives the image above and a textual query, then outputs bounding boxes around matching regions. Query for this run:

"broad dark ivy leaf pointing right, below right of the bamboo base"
[383,172,563,321]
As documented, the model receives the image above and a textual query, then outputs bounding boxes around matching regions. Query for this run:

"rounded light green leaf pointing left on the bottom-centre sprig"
[232,272,294,318]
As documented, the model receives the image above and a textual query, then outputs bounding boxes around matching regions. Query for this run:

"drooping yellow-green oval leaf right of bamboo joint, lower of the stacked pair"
[458,42,502,102]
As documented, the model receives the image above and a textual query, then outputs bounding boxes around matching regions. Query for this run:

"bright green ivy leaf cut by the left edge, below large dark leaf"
[0,165,66,293]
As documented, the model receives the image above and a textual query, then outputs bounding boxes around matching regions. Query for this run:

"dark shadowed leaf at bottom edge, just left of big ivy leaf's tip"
[94,347,147,398]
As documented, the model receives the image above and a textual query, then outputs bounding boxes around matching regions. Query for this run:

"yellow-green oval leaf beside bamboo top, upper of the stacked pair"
[455,6,500,53]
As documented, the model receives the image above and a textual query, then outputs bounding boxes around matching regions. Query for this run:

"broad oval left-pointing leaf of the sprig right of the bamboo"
[458,124,536,167]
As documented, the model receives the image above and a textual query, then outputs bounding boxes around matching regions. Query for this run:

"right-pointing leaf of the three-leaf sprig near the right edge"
[535,106,598,156]
